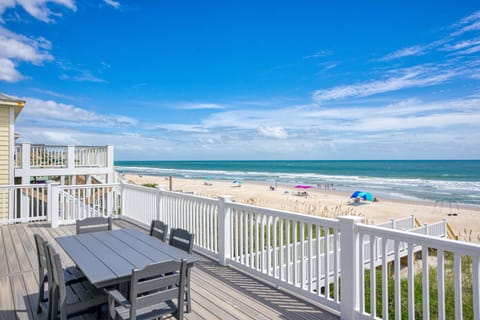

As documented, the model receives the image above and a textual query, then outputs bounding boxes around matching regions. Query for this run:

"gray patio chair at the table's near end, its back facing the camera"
[108,260,187,320]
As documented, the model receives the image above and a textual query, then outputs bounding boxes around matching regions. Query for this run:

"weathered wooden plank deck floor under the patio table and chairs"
[0,221,338,320]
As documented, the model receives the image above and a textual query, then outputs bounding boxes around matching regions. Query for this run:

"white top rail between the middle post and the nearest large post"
[226,202,339,228]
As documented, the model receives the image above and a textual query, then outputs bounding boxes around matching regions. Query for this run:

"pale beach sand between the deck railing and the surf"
[122,174,480,243]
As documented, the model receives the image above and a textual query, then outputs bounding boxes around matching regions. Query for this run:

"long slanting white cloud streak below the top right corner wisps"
[313,66,456,102]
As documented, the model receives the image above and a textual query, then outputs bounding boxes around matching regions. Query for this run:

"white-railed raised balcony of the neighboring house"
[15,143,113,183]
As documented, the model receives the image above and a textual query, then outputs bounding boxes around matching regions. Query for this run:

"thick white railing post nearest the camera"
[337,216,363,320]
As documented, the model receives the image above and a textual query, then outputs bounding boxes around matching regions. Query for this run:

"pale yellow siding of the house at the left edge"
[0,107,10,219]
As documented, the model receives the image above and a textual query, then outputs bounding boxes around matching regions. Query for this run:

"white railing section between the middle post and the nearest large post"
[225,202,340,311]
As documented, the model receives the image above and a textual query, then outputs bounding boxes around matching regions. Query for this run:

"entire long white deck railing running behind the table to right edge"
[16,184,480,319]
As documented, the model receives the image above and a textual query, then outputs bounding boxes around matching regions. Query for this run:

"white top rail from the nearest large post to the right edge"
[355,224,480,257]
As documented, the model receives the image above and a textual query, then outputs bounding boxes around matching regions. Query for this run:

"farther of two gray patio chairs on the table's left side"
[33,234,86,313]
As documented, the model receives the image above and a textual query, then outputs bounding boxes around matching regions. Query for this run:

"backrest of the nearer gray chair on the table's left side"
[45,244,67,315]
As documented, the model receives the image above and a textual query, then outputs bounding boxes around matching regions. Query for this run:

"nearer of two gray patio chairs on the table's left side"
[45,244,108,320]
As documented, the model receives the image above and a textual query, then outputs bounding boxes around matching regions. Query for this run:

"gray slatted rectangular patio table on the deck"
[56,229,198,288]
